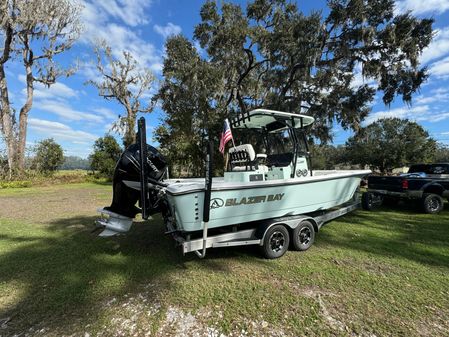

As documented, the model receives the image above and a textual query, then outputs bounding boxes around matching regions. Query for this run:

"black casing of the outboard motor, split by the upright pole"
[105,144,167,218]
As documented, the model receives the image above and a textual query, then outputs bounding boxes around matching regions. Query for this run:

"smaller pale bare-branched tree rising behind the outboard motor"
[87,41,155,148]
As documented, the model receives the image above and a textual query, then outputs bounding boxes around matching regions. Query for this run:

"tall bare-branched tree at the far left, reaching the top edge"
[0,0,81,175]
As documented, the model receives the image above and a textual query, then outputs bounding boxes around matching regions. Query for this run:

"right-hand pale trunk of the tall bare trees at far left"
[17,64,34,171]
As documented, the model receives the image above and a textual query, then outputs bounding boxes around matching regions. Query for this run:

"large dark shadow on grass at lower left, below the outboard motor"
[0,216,222,336]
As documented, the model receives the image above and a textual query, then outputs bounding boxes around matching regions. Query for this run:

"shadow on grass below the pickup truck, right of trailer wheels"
[318,204,449,268]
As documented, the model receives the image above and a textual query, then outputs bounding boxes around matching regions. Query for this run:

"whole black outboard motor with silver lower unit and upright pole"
[95,118,167,236]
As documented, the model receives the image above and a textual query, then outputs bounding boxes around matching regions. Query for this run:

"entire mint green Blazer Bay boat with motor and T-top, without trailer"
[97,109,371,256]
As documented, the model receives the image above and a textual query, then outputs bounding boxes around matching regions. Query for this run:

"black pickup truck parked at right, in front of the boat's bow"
[362,163,449,214]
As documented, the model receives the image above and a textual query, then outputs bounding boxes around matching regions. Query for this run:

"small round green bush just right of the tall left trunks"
[33,138,64,174]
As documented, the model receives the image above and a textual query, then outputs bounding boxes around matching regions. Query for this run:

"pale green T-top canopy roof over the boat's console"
[231,109,315,131]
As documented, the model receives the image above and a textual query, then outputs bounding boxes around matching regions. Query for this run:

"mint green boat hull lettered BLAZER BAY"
[167,170,370,232]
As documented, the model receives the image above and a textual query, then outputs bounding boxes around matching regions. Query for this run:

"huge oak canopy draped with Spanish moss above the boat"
[156,0,433,172]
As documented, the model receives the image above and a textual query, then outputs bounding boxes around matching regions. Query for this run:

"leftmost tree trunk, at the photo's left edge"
[0,64,17,178]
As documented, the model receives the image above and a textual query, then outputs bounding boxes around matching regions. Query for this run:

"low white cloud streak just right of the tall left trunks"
[28,118,98,141]
